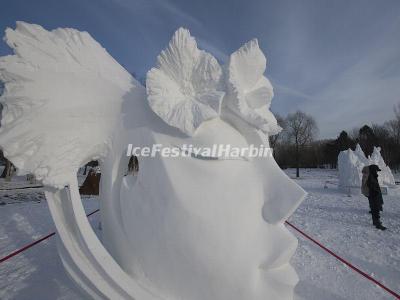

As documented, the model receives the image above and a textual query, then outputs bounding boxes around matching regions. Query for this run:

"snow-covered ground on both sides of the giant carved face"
[0,170,400,300]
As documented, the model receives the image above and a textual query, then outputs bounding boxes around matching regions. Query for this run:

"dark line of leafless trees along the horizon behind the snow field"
[269,104,400,176]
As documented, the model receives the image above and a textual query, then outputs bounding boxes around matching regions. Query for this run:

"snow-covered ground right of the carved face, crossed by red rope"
[287,170,400,300]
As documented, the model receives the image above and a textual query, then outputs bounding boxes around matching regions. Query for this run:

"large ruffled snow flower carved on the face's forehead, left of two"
[146,28,225,136]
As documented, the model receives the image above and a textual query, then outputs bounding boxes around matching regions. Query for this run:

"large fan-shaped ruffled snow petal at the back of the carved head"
[0,22,145,188]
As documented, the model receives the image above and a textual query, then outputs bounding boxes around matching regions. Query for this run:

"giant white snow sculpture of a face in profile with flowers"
[0,22,305,300]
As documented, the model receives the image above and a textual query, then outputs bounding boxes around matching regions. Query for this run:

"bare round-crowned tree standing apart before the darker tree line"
[285,111,318,177]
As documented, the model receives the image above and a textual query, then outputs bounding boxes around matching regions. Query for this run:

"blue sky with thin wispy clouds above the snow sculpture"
[0,0,400,138]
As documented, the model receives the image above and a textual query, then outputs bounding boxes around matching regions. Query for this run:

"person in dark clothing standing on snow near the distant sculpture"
[367,165,386,230]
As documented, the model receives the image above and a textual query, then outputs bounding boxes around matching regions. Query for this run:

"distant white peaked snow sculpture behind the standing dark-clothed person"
[338,144,395,192]
